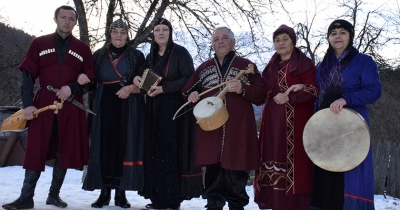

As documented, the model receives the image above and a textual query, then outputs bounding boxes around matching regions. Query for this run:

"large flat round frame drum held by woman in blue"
[303,108,370,172]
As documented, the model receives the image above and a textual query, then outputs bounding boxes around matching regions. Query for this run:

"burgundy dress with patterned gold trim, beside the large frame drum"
[254,57,317,210]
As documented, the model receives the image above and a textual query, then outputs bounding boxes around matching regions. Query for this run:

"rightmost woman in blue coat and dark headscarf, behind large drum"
[311,20,382,210]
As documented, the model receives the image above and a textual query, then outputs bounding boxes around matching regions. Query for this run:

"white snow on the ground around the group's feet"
[0,166,400,210]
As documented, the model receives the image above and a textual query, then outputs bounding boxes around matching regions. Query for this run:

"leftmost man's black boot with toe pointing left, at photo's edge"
[2,170,40,209]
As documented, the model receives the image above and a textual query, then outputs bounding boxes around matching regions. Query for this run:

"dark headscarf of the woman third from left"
[149,18,175,76]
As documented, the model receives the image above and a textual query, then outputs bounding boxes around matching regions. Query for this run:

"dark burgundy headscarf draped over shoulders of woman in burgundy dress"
[264,25,313,89]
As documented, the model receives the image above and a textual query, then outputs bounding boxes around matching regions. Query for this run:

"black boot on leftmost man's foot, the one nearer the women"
[46,153,68,208]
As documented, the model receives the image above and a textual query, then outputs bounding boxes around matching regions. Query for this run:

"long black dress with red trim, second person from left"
[83,45,145,190]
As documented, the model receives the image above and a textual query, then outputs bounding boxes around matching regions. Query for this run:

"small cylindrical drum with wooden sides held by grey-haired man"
[193,97,229,131]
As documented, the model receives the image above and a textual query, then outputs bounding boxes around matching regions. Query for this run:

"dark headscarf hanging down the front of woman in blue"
[317,20,358,111]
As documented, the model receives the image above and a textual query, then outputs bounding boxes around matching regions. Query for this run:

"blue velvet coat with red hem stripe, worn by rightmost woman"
[317,53,382,209]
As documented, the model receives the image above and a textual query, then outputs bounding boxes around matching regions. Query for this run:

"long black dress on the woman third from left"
[139,44,203,209]
